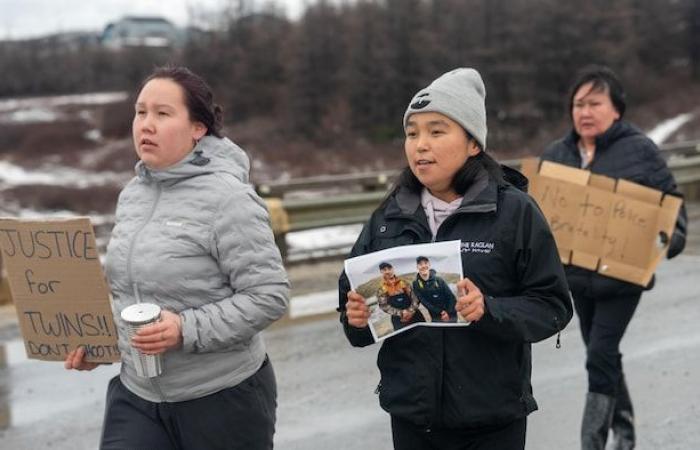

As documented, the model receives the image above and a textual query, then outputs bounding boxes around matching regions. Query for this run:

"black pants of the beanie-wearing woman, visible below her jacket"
[391,416,527,450]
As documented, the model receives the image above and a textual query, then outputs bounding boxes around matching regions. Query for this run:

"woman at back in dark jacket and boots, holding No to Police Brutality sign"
[542,66,687,450]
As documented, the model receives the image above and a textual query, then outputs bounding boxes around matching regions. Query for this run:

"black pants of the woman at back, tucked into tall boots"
[571,284,641,397]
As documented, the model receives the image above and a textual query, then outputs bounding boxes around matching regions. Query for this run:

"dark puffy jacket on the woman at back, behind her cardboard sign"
[542,121,688,296]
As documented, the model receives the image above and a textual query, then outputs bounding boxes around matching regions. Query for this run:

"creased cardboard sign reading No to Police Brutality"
[522,158,683,286]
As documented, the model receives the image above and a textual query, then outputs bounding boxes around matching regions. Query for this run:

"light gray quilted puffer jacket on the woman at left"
[106,136,289,402]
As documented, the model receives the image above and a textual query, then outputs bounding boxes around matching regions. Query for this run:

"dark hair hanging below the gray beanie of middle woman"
[390,150,505,196]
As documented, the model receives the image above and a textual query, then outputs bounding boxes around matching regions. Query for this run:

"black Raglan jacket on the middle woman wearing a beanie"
[338,165,573,429]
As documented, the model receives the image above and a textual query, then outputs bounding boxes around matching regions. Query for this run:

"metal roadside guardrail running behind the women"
[266,141,700,254]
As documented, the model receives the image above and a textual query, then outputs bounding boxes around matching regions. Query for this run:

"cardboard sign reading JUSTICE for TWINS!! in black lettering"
[0,218,119,362]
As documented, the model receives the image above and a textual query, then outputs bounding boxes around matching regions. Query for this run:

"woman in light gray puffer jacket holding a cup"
[66,67,289,449]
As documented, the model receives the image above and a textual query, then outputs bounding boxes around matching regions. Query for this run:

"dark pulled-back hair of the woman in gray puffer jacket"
[136,66,224,138]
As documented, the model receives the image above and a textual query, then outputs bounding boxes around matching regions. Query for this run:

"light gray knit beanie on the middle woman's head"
[403,67,487,150]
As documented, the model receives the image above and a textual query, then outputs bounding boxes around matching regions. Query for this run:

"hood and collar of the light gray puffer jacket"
[135,136,250,184]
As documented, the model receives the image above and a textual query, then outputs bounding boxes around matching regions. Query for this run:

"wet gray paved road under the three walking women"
[0,251,700,450]
